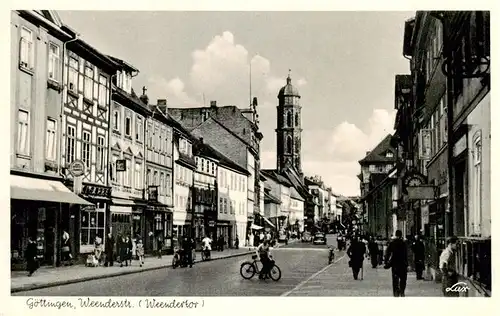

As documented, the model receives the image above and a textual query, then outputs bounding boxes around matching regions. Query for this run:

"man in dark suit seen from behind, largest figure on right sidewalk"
[384,229,408,297]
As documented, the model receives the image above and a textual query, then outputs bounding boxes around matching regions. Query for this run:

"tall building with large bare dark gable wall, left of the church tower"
[169,98,263,236]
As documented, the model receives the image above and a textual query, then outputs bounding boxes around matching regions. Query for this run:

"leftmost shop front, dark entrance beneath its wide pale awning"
[10,175,92,269]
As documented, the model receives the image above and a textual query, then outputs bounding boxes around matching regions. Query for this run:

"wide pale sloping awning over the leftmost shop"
[10,175,94,205]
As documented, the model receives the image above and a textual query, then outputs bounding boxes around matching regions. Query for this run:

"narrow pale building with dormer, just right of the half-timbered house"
[109,56,151,240]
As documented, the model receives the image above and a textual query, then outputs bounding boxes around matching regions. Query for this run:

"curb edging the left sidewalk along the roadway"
[10,251,254,294]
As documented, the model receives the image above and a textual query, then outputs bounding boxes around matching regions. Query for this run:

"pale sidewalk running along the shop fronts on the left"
[11,247,254,293]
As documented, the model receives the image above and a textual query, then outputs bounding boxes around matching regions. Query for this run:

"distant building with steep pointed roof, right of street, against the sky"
[358,135,396,238]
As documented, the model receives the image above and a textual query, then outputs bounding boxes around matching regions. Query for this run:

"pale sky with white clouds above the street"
[58,11,414,196]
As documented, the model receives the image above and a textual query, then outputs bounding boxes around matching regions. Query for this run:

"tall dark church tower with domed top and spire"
[276,73,302,174]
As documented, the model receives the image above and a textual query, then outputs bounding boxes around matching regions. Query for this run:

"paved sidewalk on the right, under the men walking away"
[286,252,443,297]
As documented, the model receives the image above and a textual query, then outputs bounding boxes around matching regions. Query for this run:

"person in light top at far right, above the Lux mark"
[439,236,459,297]
